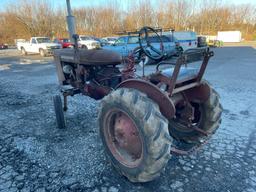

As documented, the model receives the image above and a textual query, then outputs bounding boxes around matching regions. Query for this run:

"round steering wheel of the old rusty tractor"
[139,26,164,60]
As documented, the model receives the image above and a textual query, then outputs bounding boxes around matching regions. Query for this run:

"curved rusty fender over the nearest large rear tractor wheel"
[116,79,176,120]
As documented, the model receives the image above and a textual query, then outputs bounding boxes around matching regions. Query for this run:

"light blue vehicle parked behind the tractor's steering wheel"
[103,35,176,61]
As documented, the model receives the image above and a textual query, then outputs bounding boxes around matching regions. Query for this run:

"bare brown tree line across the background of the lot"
[0,0,256,43]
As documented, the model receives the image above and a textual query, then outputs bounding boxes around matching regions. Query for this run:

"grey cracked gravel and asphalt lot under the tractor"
[0,47,256,192]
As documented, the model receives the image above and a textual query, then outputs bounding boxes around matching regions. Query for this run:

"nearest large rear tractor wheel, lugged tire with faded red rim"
[99,88,172,182]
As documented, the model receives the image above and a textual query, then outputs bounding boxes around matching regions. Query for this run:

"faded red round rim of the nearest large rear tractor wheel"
[104,109,143,168]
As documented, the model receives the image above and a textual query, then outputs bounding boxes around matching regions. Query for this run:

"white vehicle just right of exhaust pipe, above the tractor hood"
[78,35,101,49]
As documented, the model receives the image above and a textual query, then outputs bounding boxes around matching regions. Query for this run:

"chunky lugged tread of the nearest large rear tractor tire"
[99,88,172,182]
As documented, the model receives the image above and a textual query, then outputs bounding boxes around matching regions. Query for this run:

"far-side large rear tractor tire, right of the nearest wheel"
[169,81,223,145]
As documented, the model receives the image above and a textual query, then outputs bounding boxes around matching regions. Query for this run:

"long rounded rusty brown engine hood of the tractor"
[54,49,122,66]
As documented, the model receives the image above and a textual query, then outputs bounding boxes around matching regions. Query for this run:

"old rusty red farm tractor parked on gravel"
[53,27,222,182]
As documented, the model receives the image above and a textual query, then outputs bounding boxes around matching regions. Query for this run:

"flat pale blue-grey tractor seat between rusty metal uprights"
[162,67,198,80]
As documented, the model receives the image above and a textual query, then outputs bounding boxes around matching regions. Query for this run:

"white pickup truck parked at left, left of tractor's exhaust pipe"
[17,37,61,57]
